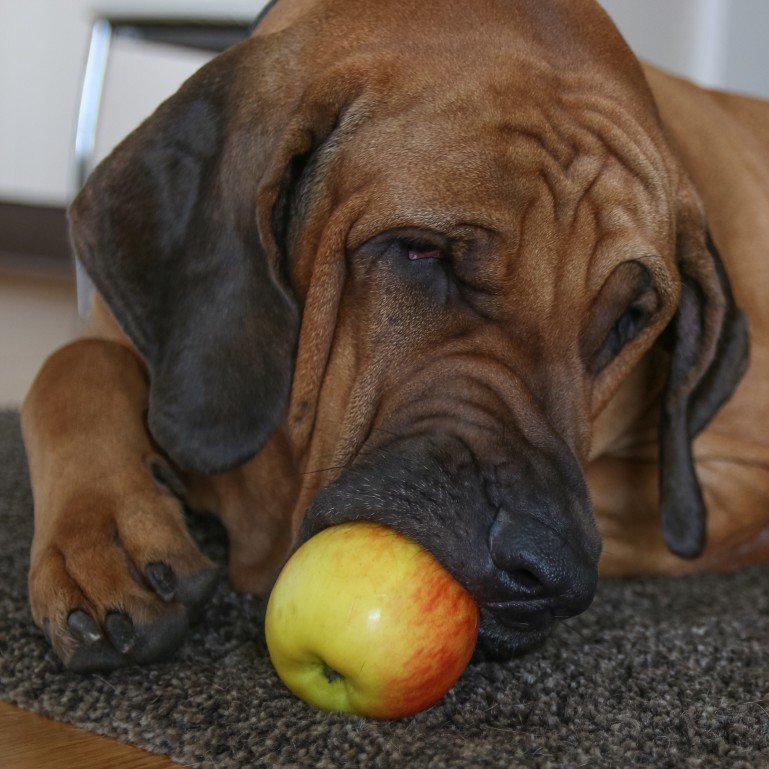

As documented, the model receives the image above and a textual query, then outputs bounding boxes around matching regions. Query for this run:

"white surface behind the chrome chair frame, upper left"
[0,0,266,205]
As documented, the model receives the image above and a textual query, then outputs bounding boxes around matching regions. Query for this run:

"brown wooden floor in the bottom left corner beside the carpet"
[0,702,179,769]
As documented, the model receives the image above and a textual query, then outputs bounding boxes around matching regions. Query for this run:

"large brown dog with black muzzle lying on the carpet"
[23,0,769,669]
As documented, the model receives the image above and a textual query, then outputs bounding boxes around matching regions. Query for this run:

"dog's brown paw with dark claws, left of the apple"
[29,462,220,671]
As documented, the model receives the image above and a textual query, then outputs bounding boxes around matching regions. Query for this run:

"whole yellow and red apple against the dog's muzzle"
[265,522,478,719]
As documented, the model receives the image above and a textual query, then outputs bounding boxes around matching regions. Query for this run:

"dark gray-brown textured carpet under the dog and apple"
[0,404,769,769]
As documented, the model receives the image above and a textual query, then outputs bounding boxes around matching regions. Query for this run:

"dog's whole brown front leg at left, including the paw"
[22,338,218,670]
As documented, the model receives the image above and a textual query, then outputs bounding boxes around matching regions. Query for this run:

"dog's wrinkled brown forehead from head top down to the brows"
[276,0,675,292]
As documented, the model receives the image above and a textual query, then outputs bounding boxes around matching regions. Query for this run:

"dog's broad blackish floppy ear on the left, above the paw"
[70,41,311,473]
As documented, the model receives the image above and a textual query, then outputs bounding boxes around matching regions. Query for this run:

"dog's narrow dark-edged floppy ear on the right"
[659,179,748,558]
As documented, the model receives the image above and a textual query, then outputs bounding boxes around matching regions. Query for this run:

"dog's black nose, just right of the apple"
[489,509,598,624]
